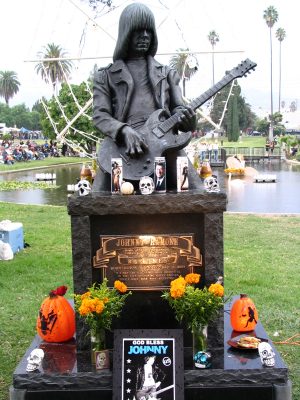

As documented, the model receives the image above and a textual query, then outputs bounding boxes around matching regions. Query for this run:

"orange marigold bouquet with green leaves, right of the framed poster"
[162,273,224,331]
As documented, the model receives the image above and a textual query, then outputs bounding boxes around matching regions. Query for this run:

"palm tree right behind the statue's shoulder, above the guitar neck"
[169,49,198,96]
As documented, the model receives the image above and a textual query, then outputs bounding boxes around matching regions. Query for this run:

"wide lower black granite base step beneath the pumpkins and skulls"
[11,304,291,400]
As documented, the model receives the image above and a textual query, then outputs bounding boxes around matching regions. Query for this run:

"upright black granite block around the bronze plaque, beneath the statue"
[68,190,227,349]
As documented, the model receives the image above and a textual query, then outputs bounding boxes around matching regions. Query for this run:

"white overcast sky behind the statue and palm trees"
[0,0,300,119]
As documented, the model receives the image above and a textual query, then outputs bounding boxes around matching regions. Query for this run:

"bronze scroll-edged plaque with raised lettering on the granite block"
[93,234,202,290]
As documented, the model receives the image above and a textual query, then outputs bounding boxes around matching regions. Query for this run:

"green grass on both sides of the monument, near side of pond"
[0,202,300,400]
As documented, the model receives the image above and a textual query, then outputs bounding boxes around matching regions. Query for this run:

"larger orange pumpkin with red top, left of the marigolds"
[36,286,75,343]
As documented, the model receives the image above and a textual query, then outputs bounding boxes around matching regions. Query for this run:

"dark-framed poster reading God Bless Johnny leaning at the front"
[113,329,184,400]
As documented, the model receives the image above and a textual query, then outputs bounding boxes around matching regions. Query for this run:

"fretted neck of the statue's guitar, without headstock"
[159,74,235,133]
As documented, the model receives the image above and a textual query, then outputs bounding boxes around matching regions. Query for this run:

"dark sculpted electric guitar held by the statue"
[98,58,257,181]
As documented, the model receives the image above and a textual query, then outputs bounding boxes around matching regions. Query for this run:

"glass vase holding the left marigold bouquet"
[91,328,109,370]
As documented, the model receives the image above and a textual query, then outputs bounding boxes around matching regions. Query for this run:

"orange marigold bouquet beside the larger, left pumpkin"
[74,278,131,332]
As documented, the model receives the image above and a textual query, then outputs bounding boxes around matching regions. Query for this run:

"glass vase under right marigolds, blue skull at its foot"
[192,324,211,368]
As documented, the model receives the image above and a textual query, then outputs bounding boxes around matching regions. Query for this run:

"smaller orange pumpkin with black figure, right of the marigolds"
[230,294,258,332]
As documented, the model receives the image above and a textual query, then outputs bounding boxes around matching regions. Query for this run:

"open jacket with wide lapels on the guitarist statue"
[93,56,188,141]
